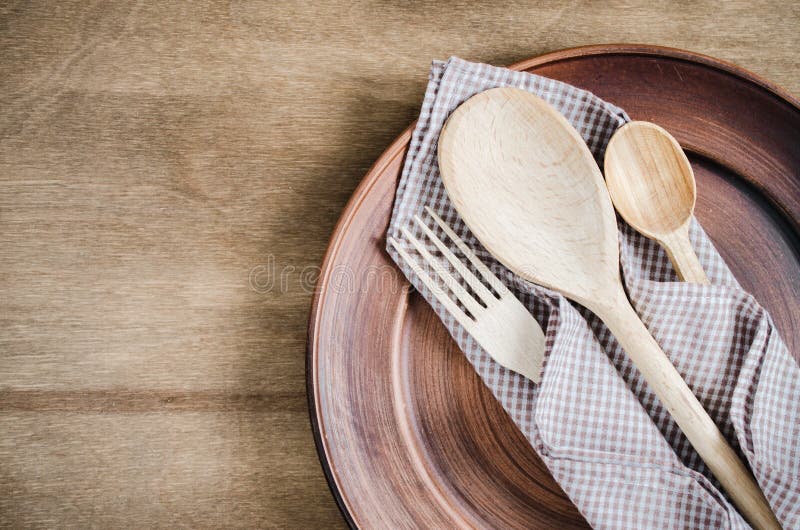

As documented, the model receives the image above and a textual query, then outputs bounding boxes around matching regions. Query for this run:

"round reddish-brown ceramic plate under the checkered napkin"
[307,45,800,528]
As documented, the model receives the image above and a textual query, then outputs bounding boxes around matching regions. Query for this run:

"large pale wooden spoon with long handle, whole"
[439,88,780,528]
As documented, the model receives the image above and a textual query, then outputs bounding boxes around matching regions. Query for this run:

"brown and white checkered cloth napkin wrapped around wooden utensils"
[387,58,800,529]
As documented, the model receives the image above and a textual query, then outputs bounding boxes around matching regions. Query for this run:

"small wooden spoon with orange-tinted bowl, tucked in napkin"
[605,121,708,283]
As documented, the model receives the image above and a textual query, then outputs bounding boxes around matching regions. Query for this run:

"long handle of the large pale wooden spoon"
[595,290,781,529]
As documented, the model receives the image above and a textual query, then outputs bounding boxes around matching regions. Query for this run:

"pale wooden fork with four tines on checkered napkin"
[389,207,544,383]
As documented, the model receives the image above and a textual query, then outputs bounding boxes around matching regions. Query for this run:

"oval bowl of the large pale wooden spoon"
[439,88,619,307]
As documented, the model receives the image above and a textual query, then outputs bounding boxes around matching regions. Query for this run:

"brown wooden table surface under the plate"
[0,0,800,528]
